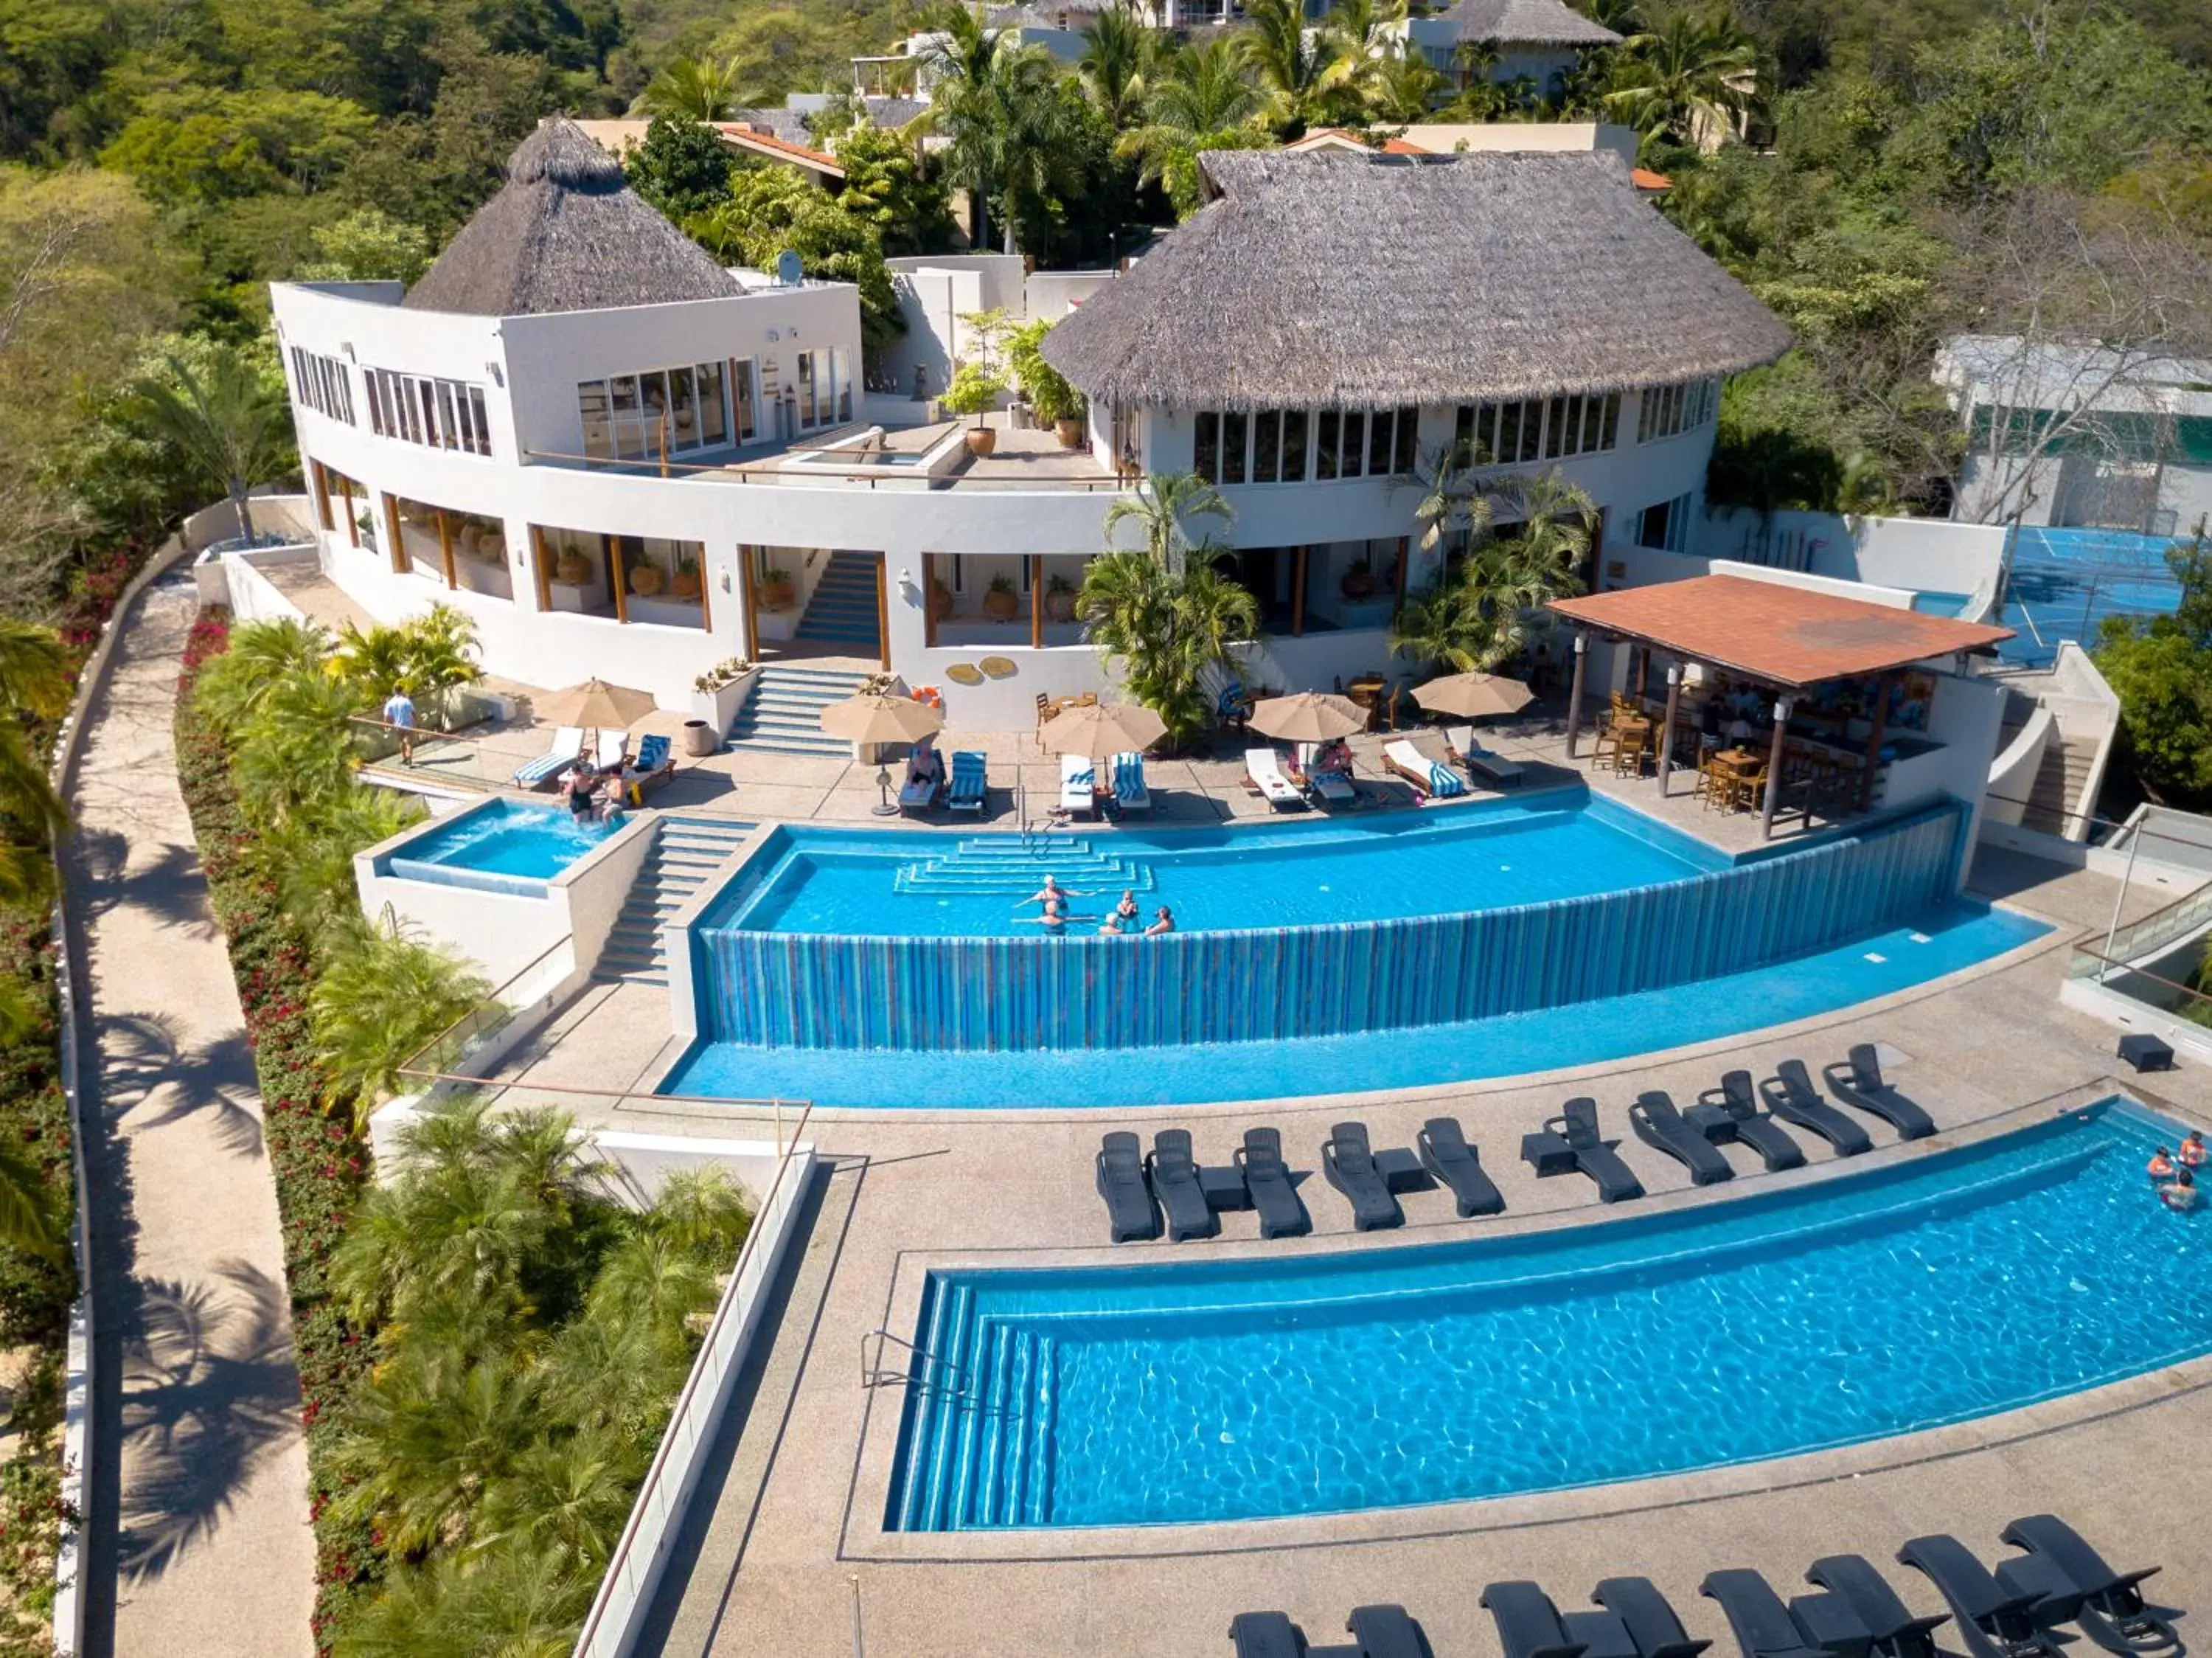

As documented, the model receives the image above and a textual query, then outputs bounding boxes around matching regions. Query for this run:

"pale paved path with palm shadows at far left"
[69,575,314,1658]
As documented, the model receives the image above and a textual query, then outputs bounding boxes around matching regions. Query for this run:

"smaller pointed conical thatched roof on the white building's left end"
[403,117,741,316]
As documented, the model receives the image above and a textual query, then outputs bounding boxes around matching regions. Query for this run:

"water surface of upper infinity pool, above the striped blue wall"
[703,790,1732,939]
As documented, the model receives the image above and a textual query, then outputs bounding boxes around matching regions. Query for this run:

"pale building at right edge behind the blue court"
[1935,334,2212,535]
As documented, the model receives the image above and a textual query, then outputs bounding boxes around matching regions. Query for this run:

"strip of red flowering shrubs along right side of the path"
[177,611,383,1649]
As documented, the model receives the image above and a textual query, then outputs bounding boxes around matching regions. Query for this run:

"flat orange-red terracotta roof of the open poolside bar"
[1551,575,2013,688]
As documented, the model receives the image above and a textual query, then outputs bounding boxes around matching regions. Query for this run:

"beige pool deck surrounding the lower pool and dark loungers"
[462,848,2212,1658]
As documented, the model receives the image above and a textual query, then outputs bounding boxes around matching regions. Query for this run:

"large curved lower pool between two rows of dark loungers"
[885,1100,2212,1532]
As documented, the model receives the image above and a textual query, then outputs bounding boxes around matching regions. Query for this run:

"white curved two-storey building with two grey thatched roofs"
[274,122,1790,728]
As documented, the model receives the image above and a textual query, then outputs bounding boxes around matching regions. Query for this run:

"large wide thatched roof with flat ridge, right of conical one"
[1044,150,1790,409]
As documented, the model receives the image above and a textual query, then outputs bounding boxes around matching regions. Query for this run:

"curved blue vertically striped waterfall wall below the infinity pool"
[692,801,1966,1050]
